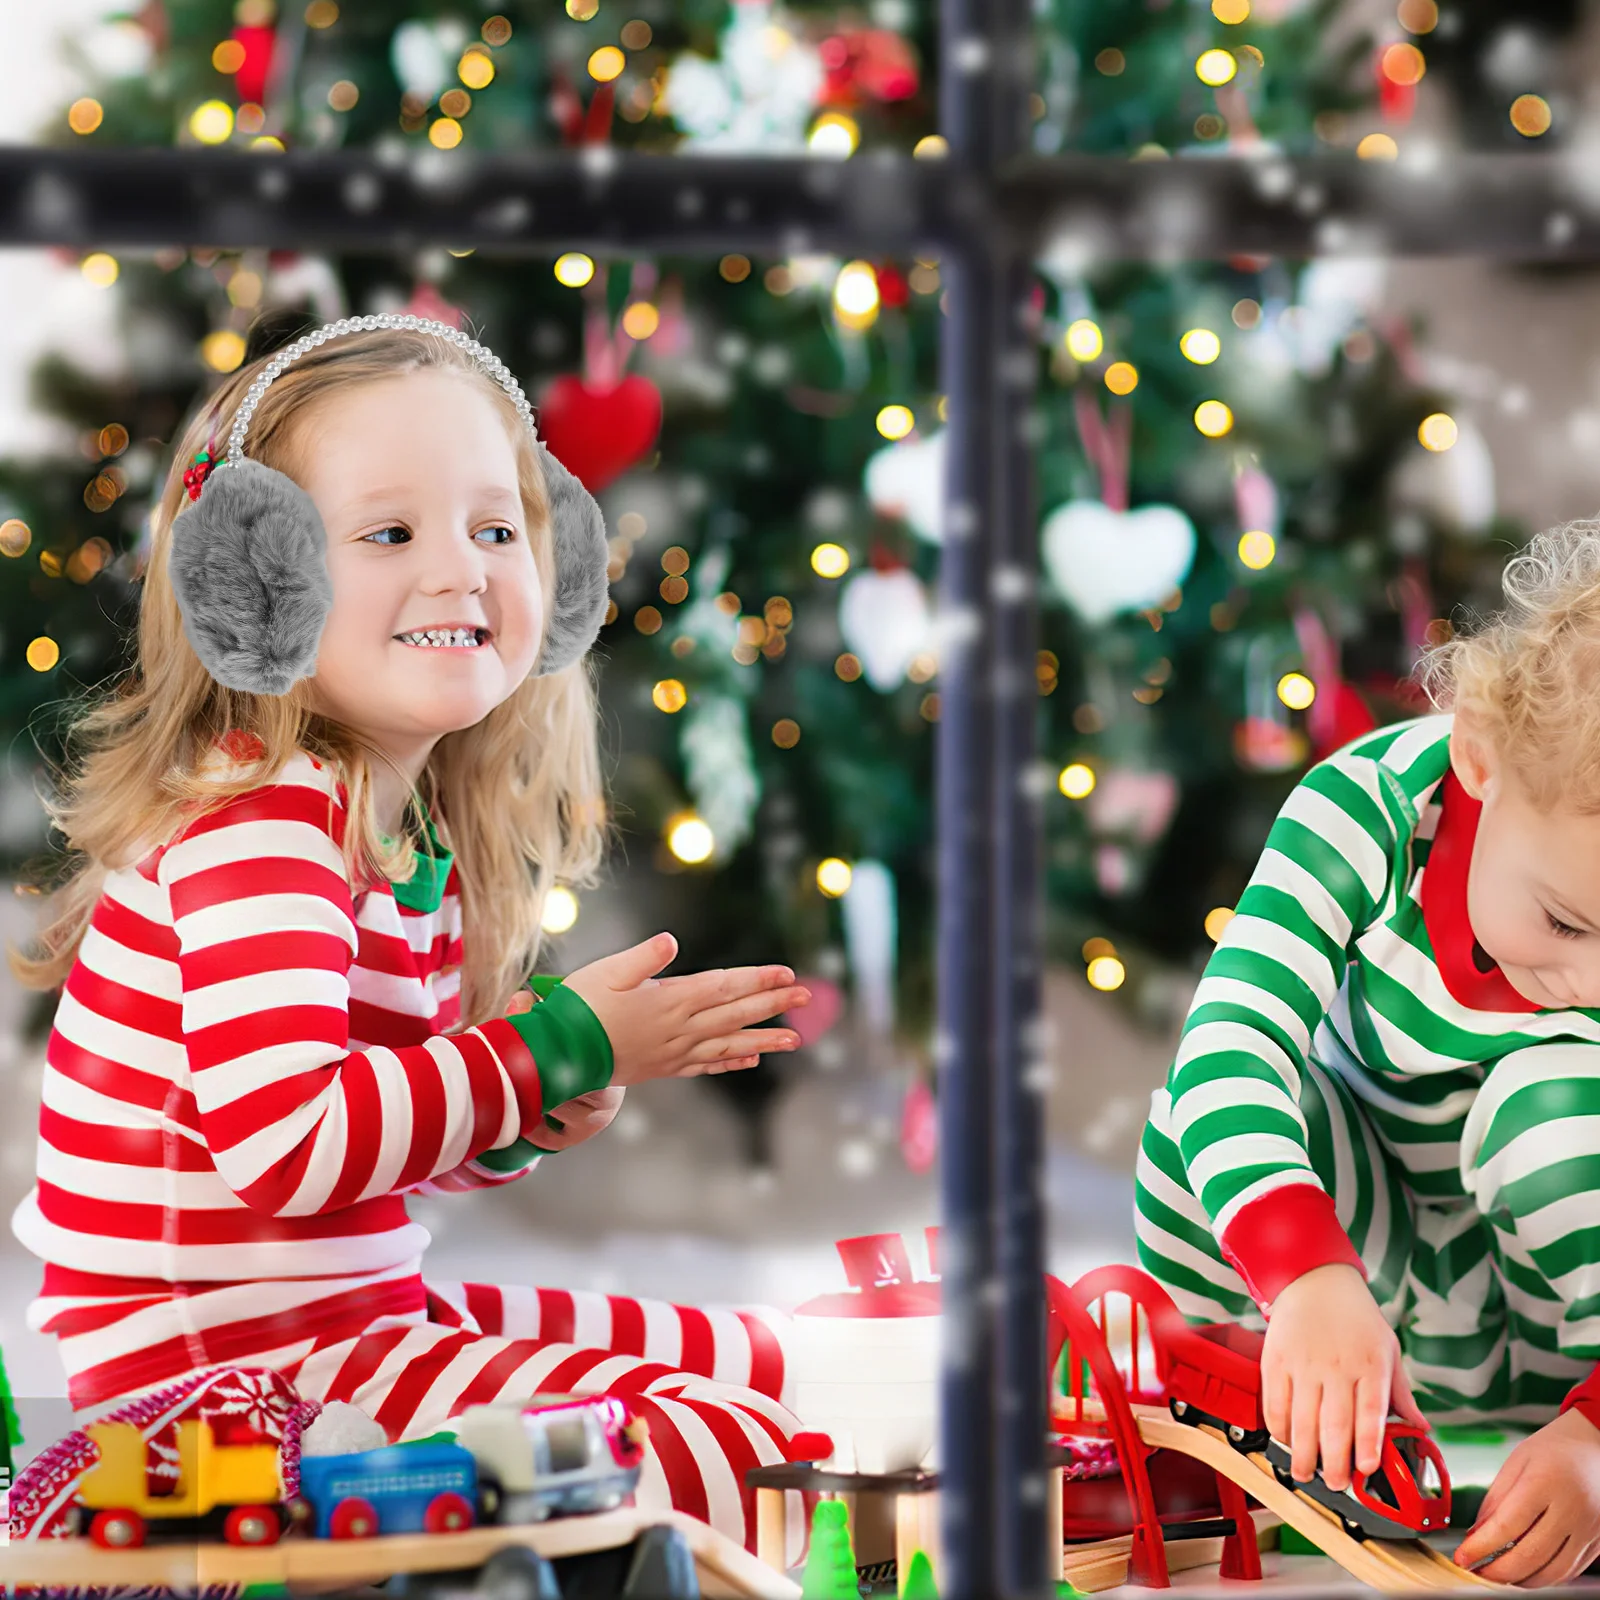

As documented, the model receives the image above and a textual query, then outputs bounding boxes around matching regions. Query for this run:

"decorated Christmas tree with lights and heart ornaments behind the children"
[0,0,1571,1152]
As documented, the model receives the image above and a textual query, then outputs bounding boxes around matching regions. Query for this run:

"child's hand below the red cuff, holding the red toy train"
[1261,1264,1427,1490]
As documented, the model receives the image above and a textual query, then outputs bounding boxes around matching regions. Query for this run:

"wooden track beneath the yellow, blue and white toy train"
[0,1506,800,1600]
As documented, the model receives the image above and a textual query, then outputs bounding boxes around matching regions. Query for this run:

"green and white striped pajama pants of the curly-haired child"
[1134,1043,1600,1424]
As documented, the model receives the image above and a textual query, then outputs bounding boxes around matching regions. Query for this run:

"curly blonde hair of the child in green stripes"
[1418,520,1600,813]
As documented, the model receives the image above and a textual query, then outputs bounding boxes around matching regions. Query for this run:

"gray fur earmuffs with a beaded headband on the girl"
[170,312,610,694]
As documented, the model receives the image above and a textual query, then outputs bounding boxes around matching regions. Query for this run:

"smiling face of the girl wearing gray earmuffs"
[296,370,544,793]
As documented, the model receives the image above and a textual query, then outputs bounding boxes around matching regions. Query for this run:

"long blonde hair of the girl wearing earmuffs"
[6,330,605,1026]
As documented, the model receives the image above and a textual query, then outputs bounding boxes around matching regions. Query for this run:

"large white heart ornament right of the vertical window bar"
[1040,501,1195,622]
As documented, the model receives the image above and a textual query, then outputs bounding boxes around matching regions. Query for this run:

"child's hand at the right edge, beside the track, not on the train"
[1456,1411,1600,1589]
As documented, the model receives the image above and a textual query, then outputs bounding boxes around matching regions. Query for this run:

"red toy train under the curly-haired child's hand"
[1162,1325,1450,1539]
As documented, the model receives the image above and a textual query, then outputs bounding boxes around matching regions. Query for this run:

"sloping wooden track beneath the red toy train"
[1133,1405,1512,1594]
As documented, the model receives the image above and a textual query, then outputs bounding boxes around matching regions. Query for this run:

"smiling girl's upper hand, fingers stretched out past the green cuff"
[566,933,811,1088]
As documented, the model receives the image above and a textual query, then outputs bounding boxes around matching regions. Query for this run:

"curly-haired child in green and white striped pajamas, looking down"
[1136,522,1600,1586]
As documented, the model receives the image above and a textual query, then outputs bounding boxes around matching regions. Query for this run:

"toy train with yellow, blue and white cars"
[69,1395,646,1549]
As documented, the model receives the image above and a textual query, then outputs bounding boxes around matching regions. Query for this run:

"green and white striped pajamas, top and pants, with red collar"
[1136,717,1600,1426]
